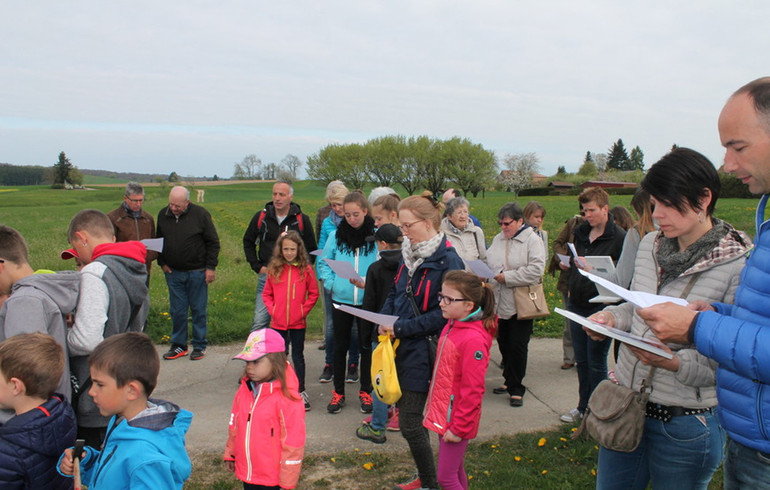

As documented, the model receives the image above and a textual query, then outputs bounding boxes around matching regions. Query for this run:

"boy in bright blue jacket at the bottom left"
[58,332,192,490]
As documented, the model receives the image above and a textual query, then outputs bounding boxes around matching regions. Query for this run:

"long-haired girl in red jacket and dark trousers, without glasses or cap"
[262,231,318,411]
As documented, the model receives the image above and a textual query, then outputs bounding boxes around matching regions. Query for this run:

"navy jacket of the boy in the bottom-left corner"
[0,395,76,490]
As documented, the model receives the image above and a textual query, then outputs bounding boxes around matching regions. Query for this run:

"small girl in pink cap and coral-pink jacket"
[224,328,305,490]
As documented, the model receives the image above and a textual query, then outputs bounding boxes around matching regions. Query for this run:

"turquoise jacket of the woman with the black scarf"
[316,230,377,306]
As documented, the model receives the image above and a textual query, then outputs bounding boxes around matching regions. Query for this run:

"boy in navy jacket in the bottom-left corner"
[0,333,75,490]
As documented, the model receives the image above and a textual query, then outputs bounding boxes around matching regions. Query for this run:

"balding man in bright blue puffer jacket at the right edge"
[640,77,770,489]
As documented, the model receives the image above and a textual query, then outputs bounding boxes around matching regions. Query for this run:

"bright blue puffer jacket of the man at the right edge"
[695,195,770,453]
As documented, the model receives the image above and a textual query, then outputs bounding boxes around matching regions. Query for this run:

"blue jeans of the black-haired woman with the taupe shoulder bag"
[596,412,728,490]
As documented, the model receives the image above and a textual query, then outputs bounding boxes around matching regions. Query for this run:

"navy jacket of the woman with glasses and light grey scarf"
[381,235,465,393]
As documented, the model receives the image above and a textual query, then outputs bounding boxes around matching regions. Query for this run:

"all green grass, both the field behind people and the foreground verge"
[0,181,736,489]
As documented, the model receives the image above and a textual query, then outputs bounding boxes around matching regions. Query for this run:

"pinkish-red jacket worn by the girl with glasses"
[423,320,492,439]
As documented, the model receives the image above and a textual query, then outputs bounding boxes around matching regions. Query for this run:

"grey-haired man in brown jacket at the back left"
[107,182,158,280]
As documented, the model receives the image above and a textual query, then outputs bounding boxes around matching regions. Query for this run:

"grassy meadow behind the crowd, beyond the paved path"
[0,181,757,343]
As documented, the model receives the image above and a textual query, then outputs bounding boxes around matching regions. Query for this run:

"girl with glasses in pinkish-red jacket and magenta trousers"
[423,270,497,490]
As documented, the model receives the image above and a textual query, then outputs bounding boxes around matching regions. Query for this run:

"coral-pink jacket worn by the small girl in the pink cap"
[224,363,305,488]
